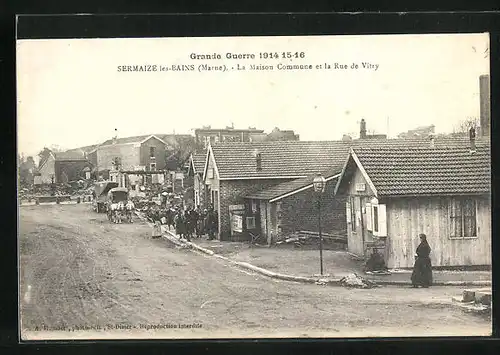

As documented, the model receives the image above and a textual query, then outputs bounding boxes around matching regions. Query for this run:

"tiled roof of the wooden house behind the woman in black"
[353,144,491,196]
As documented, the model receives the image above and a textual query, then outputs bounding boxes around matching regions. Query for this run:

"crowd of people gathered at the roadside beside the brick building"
[147,206,218,241]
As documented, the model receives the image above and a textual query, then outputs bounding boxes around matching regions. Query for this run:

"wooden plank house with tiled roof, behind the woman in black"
[336,141,491,268]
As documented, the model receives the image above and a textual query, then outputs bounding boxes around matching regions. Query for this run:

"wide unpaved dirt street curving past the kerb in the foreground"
[19,204,491,338]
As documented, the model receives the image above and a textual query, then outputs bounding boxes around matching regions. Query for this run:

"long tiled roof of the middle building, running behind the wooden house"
[212,138,489,179]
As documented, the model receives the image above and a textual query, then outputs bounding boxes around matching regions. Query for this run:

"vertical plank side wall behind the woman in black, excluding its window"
[381,197,491,268]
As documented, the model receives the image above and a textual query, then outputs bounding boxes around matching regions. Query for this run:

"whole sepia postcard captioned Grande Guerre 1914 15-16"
[17,33,492,340]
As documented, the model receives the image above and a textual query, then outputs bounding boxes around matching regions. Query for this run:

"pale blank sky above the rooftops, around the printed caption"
[17,34,489,159]
